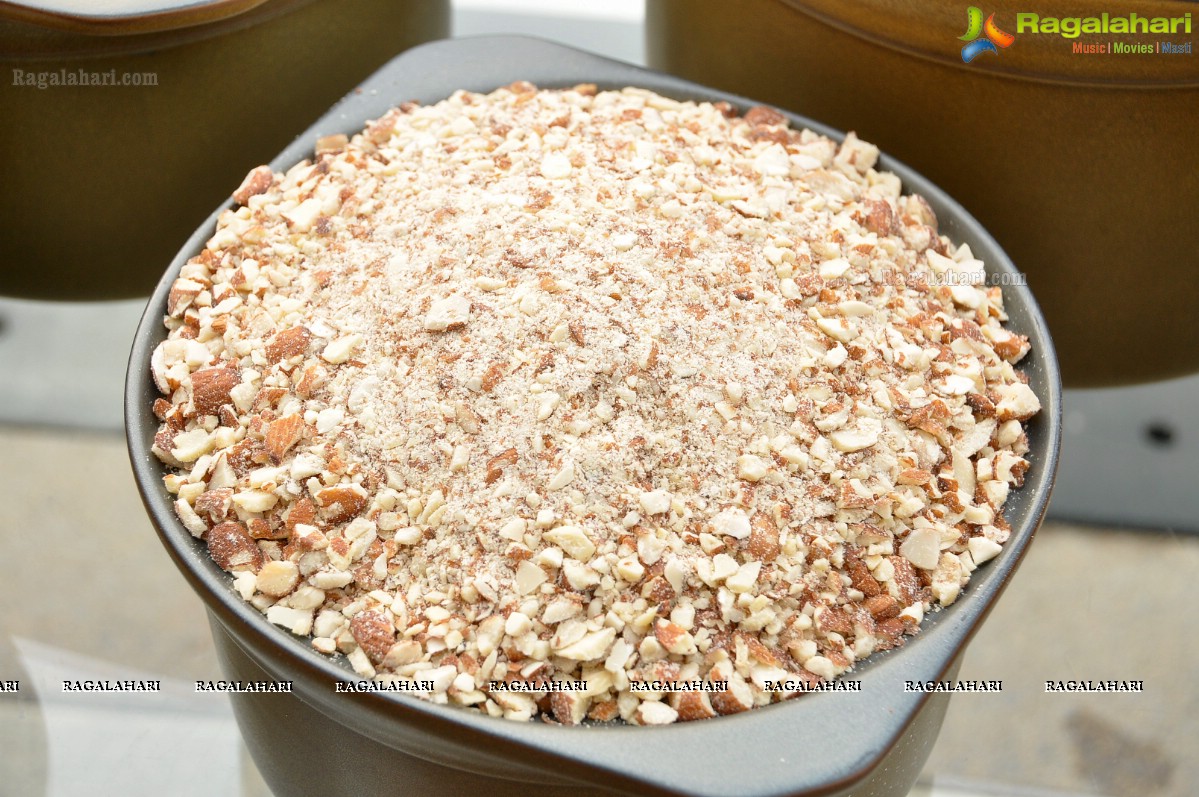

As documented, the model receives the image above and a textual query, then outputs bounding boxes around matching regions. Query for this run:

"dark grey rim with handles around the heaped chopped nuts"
[125,36,1061,797]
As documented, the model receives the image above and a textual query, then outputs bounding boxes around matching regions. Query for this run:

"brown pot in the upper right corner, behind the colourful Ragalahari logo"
[646,0,1199,386]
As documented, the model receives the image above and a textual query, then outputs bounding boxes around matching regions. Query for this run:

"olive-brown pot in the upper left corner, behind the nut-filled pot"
[0,0,448,298]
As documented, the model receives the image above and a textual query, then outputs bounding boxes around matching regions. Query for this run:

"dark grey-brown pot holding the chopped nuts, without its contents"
[125,37,1061,797]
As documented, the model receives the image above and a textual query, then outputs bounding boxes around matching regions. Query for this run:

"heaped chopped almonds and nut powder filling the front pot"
[151,83,1040,724]
